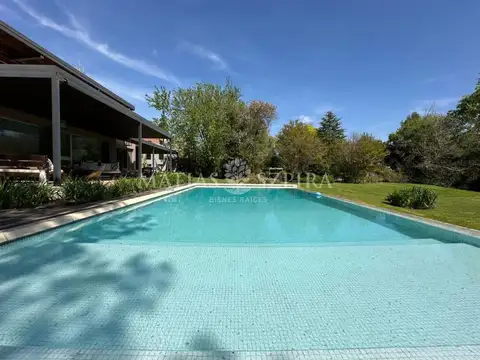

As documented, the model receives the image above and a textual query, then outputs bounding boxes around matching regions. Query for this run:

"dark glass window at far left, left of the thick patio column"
[0,118,40,154]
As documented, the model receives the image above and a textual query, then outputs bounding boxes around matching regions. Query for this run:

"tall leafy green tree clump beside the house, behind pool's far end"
[146,80,277,176]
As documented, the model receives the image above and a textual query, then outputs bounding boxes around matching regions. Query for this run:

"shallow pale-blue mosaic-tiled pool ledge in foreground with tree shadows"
[0,240,480,359]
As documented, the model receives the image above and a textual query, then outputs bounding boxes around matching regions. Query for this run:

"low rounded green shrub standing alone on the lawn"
[385,186,438,209]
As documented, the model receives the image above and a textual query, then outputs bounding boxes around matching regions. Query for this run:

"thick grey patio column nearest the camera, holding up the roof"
[52,74,62,184]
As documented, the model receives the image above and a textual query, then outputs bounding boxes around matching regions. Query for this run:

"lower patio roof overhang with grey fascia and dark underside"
[0,64,170,140]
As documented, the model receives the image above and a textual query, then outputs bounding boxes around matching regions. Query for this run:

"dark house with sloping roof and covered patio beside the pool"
[0,21,171,181]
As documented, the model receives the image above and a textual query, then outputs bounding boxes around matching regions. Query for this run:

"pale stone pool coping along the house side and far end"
[0,183,298,246]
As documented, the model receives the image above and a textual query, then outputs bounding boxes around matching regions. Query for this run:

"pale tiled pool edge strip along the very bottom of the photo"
[0,345,480,360]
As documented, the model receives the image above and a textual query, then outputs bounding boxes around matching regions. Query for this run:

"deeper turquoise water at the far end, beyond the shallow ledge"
[57,188,462,246]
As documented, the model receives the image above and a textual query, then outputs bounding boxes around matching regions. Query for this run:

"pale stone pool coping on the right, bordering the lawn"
[298,187,480,247]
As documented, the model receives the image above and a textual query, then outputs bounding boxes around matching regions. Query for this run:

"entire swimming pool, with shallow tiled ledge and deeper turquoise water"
[0,188,480,358]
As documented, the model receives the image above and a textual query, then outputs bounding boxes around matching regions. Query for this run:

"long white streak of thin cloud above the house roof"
[13,0,180,85]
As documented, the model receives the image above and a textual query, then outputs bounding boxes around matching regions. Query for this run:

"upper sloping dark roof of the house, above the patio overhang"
[0,20,135,110]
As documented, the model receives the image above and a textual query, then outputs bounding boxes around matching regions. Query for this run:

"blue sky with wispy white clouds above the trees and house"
[0,0,480,139]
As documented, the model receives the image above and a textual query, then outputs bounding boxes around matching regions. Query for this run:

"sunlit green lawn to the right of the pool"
[301,183,480,230]
